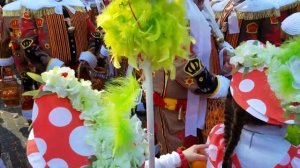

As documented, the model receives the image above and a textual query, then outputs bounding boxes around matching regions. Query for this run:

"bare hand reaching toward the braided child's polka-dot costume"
[182,144,208,162]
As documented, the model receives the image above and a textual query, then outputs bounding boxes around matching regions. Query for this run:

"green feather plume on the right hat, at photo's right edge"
[268,37,300,125]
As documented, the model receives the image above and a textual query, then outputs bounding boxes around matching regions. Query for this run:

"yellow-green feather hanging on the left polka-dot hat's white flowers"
[101,77,140,155]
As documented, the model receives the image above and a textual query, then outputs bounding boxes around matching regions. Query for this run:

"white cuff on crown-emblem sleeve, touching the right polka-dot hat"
[209,75,230,99]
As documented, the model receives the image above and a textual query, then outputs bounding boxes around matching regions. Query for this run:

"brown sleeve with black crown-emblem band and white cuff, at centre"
[175,57,230,98]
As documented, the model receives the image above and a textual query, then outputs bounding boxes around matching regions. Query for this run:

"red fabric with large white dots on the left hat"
[27,94,94,168]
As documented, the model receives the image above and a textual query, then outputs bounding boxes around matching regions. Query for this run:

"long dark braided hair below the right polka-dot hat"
[222,100,266,168]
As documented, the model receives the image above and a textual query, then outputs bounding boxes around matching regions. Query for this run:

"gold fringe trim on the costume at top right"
[237,9,280,20]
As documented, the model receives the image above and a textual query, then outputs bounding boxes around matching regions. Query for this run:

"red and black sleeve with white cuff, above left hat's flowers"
[20,10,63,72]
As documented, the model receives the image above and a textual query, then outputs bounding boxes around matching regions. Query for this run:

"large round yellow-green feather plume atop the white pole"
[97,0,191,78]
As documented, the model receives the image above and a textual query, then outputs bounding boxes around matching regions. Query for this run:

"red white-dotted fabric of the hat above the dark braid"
[230,68,294,125]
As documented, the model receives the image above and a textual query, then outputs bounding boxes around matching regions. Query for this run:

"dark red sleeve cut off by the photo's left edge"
[0,16,14,66]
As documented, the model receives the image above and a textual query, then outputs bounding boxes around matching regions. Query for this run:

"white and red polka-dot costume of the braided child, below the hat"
[207,124,300,168]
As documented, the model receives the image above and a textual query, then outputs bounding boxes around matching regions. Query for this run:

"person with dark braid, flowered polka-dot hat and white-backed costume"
[207,38,300,168]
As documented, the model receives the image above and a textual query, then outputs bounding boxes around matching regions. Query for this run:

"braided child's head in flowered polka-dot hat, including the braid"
[223,37,300,168]
